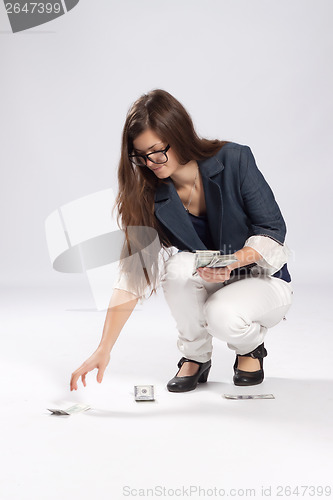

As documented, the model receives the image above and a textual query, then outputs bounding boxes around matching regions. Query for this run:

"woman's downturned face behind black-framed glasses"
[133,129,180,179]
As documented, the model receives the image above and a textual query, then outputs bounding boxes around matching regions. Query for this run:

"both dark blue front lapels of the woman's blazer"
[155,156,224,250]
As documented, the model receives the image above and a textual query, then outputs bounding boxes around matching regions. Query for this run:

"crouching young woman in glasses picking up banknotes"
[70,90,293,392]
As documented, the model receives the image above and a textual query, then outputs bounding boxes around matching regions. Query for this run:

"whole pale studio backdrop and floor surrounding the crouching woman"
[0,0,333,499]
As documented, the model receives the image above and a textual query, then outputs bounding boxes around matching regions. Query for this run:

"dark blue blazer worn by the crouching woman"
[155,142,289,281]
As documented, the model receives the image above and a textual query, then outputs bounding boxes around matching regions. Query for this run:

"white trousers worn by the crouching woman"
[161,251,293,363]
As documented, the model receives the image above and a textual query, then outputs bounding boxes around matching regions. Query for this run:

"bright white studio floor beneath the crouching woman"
[0,283,333,500]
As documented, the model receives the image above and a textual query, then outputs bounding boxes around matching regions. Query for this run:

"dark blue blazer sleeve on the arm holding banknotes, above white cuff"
[240,146,287,245]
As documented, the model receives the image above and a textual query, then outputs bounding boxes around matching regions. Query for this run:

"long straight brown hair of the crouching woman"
[114,89,229,292]
